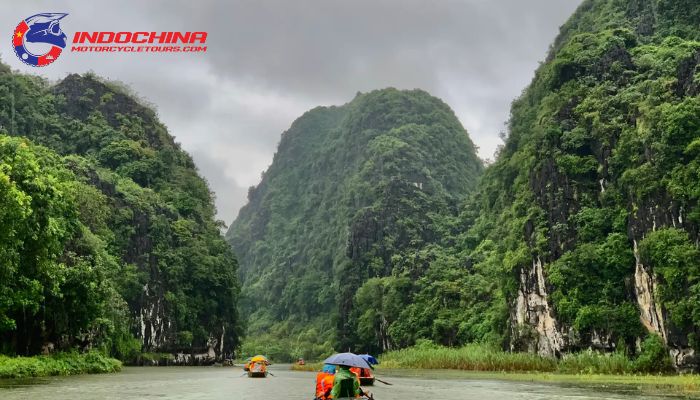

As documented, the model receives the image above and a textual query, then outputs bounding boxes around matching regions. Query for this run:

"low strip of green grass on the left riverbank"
[0,351,122,379]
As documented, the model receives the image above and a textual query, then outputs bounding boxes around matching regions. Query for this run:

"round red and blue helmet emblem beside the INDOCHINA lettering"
[12,13,68,67]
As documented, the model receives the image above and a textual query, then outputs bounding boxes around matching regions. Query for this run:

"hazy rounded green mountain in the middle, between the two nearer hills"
[227,89,482,358]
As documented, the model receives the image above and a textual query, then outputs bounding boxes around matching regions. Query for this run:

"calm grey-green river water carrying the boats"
[0,365,683,400]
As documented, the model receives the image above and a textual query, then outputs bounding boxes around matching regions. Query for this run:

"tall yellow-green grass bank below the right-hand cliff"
[370,339,700,395]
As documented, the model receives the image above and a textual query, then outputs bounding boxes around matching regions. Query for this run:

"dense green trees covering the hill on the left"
[0,68,239,362]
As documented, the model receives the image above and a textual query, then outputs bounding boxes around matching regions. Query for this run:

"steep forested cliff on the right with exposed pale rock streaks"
[477,0,700,370]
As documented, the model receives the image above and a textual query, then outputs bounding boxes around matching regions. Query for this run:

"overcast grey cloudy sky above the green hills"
[0,0,581,224]
